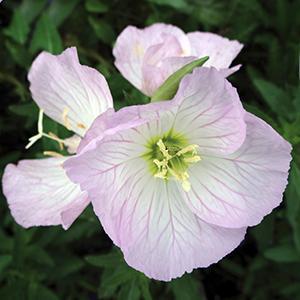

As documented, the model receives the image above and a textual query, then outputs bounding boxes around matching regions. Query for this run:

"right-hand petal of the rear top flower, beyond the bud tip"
[187,31,243,69]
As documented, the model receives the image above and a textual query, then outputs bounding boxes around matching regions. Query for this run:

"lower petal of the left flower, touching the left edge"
[2,157,89,229]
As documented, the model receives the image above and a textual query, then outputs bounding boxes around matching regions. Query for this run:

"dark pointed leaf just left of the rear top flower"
[88,17,116,45]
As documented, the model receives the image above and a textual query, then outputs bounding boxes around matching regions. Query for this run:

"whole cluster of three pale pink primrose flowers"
[3,24,291,281]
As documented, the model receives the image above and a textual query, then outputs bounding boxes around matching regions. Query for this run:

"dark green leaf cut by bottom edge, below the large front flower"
[169,275,206,300]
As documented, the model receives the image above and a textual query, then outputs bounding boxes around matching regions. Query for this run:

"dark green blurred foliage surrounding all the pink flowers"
[0,0,300,300]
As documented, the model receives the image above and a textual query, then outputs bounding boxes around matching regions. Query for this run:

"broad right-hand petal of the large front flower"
[185,113,291,228]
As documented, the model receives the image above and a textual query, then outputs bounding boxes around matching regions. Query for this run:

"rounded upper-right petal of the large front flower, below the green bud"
[173,68,246,154]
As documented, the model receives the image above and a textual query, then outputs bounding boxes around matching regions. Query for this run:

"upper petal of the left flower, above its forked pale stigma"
[28,47,113,136]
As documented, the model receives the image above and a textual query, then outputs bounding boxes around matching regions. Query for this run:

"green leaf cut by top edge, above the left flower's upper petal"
[48,0,79,27]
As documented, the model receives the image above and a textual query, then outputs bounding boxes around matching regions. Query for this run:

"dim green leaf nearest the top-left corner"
[4,9,30,45]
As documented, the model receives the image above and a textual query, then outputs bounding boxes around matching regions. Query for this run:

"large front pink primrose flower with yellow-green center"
[64,68,291,281]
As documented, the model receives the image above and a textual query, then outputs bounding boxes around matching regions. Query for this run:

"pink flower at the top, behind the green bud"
[113,23,243,96]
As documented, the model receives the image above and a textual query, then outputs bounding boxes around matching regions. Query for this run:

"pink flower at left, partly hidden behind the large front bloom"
[3,48,113,229]
